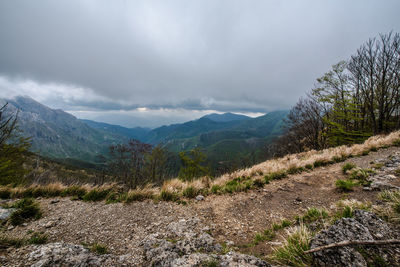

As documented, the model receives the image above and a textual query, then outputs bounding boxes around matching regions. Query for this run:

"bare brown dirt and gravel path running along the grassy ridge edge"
[0,147,400,266]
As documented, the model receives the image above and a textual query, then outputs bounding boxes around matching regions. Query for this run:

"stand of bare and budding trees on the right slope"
[276,33,400,154]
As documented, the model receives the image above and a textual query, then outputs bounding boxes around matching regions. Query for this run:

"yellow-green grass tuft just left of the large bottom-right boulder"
[272,225,312,266]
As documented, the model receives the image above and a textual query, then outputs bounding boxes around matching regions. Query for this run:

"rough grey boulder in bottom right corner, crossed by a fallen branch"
[311,210,400,266]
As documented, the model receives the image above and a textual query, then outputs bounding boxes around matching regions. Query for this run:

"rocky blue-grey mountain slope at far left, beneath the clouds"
[0,97,127,162]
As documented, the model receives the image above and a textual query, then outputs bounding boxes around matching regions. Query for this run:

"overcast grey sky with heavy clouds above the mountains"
[0,0,400,127]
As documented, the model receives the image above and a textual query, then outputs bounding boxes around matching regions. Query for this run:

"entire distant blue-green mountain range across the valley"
[0,96,288,172]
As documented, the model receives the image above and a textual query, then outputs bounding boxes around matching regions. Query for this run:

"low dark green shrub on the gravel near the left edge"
[10,198,42,225]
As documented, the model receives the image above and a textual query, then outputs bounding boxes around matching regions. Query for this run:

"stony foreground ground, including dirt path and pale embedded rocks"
[0,147,400,266]
